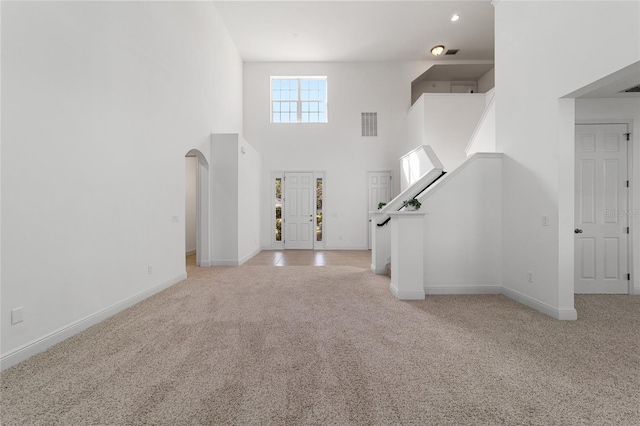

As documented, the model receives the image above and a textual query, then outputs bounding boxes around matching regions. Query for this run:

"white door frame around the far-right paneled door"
[573,119,638,295]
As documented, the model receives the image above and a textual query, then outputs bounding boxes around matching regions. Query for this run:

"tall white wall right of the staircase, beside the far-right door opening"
[495,1,640,318]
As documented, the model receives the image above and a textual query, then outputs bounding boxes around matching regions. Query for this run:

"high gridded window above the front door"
[271,77,327,123]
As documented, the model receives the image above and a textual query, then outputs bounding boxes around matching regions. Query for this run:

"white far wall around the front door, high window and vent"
[244,62,428,249]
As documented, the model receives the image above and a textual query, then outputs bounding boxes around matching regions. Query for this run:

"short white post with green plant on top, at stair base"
[389,211,425,300]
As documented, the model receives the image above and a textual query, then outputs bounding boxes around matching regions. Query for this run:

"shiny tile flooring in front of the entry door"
[187,250,371,269]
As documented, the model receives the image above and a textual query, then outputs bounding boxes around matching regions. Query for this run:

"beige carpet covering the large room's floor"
[0,266,640,426]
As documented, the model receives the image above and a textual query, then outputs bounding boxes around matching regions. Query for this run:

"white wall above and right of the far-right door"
[575,98,640,294]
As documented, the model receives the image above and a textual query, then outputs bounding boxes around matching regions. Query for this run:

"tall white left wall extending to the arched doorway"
[1,2,243,367]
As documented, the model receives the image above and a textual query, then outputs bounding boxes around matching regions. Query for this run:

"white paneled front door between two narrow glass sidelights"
[284,173,315,249]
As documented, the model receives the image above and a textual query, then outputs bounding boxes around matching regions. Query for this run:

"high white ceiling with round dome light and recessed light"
[215,0,494,62]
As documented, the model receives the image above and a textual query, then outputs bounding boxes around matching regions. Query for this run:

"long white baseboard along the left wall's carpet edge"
[0,272,187,370]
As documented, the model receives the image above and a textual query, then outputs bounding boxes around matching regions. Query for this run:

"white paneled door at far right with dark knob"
[574,124,629,294]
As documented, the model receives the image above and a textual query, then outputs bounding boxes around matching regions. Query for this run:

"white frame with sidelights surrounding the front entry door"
[269,170,327,250]
